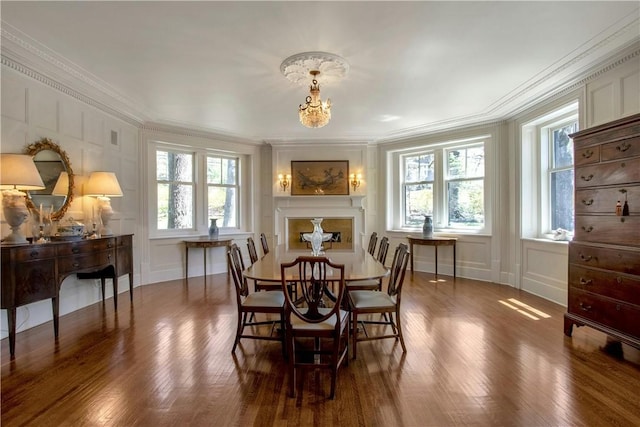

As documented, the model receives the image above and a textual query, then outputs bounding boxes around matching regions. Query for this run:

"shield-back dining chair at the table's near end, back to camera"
[280,256,350,399]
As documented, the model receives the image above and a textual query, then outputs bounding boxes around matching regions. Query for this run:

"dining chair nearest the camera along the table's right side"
[347,243,409,359]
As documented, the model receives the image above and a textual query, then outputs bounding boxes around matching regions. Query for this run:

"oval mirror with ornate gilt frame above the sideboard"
[25,138,74,221]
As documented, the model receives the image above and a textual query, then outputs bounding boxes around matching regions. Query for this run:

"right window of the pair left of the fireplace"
[207,156,238,227]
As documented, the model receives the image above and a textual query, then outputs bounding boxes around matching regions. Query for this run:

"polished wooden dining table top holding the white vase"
[243,245,390,282]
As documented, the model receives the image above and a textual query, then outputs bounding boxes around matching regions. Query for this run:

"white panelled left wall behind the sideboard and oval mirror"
[0,66,141,338]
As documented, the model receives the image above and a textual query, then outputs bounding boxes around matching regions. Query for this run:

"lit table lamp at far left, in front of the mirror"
[0,154,45,244]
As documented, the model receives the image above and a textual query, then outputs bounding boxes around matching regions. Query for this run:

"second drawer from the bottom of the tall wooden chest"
[569,265,640,306]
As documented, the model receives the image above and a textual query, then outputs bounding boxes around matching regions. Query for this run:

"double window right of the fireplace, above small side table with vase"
[401,141,485,230]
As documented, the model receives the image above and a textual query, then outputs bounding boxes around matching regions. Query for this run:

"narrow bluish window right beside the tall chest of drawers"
[545,121,578,231]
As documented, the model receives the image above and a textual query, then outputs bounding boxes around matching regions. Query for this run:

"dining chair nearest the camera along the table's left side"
[227,243,286,354]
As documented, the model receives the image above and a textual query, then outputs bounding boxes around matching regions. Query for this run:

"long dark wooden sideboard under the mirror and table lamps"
[0,234,133,357]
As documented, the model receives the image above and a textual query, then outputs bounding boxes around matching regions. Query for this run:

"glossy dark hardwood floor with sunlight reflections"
[1,273,640,426]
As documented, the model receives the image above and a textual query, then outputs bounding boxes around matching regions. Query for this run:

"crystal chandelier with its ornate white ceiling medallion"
[280,52,349,128]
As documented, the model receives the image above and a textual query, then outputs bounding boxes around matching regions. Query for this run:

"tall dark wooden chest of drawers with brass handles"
[564,114,640,347]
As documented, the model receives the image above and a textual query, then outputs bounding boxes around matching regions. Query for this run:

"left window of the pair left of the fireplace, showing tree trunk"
[156,150,194,230]
